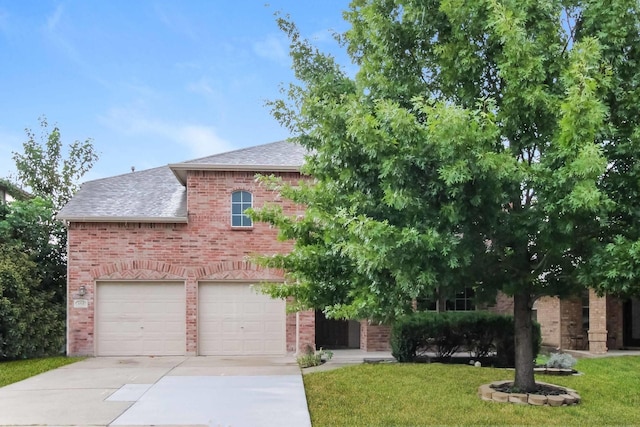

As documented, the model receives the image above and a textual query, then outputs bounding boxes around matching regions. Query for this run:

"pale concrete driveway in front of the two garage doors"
[0,357,311,427]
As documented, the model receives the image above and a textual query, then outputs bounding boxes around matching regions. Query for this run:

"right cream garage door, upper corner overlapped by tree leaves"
[198,283,286,356]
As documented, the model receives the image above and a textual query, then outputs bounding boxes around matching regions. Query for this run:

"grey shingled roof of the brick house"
[58,141,306,223]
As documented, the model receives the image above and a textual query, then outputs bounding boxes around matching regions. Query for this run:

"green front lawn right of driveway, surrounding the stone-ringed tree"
[304,356,640,427]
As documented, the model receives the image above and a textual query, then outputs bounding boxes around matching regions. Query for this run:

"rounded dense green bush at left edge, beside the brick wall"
[0,244,64,360]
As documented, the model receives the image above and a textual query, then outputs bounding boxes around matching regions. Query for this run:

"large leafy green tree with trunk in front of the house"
[256,0,640,390]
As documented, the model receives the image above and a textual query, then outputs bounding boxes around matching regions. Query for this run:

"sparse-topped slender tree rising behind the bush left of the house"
[9,117,98,311]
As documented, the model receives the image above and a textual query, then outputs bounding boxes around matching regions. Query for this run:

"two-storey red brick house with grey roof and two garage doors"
[58,141,640,356]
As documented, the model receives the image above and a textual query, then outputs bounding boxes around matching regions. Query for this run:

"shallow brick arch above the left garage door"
[91,260,188,280]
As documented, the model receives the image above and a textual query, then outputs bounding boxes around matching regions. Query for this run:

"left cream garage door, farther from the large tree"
[96,282,186,356]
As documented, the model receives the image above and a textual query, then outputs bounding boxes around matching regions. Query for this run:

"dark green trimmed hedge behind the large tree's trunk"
[391,311,541,366]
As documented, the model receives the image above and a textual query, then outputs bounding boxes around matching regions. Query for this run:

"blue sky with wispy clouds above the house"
[0,0,348,180]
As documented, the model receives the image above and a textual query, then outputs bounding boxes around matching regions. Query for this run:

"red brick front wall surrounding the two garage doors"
[68,171,313,355]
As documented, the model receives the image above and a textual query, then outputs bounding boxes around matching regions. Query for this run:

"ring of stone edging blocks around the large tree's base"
[478,380,580,406]
